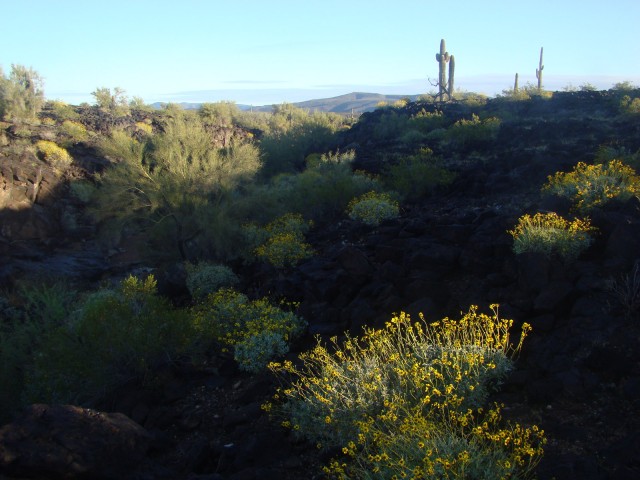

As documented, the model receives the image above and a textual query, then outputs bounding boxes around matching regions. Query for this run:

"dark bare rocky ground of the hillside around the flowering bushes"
[0,91,640,480]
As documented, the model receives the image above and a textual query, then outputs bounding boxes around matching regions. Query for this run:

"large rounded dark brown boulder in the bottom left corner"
[0,405,152,479]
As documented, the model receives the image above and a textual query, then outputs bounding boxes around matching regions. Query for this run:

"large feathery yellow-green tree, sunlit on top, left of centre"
[96,115,261,260]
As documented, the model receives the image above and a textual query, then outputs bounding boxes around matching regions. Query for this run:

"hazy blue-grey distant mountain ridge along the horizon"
[151,92,418,114]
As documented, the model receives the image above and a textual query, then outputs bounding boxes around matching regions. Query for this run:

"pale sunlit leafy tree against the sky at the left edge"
[0,65,44,122]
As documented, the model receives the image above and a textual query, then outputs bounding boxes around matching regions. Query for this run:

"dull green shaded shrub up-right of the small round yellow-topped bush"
[383,149,454,200]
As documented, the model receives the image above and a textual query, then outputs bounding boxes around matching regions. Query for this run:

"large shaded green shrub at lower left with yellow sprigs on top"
[27,276,194,404]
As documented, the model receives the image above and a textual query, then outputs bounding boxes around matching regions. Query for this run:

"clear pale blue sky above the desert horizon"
[0,0,640,105]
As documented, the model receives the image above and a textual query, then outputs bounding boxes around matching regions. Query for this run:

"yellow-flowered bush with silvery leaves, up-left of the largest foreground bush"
[193,289,306,373]
